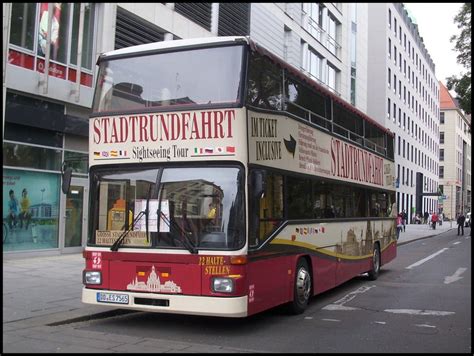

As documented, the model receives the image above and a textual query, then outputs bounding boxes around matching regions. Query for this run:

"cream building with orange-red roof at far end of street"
[439,82,472,219]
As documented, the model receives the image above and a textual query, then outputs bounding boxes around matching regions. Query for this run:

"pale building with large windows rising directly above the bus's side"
[250,3,368,112]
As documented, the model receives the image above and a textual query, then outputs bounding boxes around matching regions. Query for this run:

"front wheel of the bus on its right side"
[289,258,312,314]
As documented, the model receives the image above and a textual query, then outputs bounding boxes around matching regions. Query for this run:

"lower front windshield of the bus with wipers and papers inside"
[89,166,245,252]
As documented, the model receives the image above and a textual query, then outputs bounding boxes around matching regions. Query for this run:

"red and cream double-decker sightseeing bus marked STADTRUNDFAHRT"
[82,37,397,317]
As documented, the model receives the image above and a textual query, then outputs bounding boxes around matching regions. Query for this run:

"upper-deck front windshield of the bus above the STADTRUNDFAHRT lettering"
[93,46,243,114]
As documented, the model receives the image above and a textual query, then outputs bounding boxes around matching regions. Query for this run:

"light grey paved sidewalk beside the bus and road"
[3,222,458,353]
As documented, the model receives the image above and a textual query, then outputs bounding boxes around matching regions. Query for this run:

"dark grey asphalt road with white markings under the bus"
[74,228,472,353]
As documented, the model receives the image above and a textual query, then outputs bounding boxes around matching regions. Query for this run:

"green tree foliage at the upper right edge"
[447,3,471,114]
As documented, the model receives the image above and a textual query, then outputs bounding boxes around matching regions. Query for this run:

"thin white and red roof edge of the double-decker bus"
[97,36,394,136]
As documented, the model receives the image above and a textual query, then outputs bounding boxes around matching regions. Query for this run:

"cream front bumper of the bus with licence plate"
[82,287,248,318]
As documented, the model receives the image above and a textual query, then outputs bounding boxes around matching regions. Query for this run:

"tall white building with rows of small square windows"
[367,3,439,222]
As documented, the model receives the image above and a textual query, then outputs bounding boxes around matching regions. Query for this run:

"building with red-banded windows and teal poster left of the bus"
[3,3,217,257]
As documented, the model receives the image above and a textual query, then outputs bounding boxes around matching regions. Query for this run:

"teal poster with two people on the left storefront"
[2,169,60,251]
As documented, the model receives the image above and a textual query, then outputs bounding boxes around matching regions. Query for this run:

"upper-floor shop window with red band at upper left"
[9,3,96,87]
